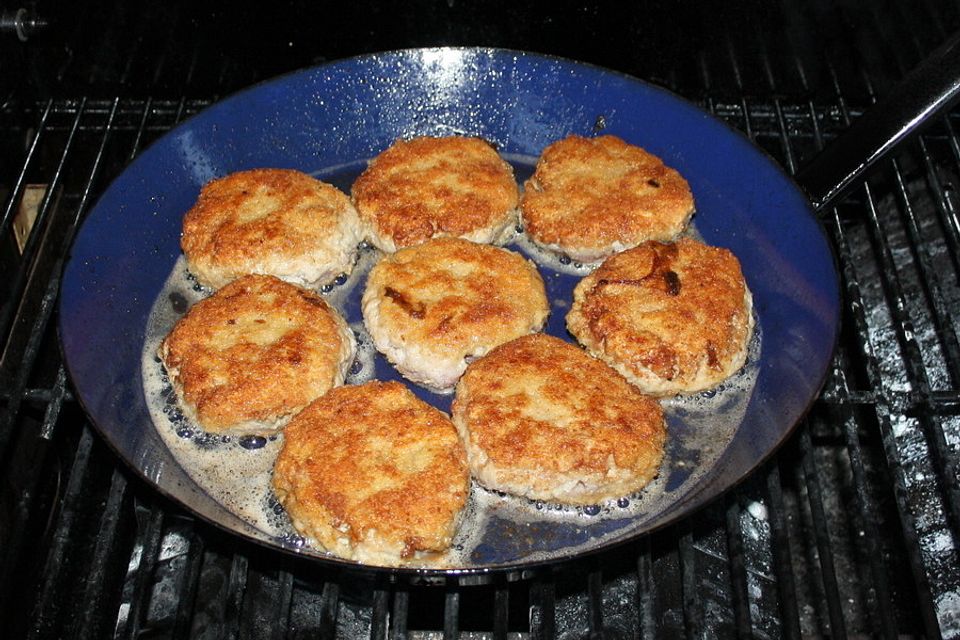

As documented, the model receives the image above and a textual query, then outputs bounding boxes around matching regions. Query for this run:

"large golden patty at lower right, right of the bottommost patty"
[453,334,666,504]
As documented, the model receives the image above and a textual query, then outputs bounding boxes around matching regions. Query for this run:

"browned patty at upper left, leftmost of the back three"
[180,169,360,288]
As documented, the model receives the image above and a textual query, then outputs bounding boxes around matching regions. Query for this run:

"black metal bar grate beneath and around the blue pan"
[0,3,960,638]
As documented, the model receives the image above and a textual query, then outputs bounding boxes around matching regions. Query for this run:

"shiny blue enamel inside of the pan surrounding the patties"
[60,49,839,571]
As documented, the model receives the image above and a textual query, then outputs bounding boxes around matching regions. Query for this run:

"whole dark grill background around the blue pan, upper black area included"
[0,0,960,638]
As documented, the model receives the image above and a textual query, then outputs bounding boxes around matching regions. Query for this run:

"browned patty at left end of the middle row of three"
[160,276,355,433]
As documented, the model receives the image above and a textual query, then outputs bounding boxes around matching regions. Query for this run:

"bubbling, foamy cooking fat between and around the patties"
[141,156,762,568]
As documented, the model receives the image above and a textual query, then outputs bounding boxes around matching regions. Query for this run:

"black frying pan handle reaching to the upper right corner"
[794,32,960,211]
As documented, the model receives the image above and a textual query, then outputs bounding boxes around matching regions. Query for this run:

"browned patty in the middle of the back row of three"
[352,136,519,252]
